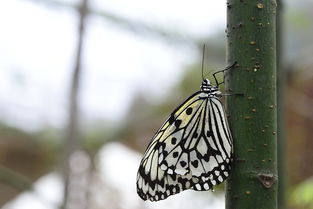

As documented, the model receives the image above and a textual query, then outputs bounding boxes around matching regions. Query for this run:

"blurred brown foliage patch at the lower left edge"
[0,124,57,205]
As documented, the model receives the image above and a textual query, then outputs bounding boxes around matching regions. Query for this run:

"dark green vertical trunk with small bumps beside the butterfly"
[226,0,277,209]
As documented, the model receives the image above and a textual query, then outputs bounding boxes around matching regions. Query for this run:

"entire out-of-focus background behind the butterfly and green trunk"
[0,0,313,209]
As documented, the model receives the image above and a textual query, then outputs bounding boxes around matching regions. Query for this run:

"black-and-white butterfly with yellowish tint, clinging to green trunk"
[137,62,236,201]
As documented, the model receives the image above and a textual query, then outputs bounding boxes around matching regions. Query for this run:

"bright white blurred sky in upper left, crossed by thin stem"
[0,0,226,130]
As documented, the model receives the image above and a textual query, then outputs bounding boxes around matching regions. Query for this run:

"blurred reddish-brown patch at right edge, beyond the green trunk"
[286,75,313,186]
